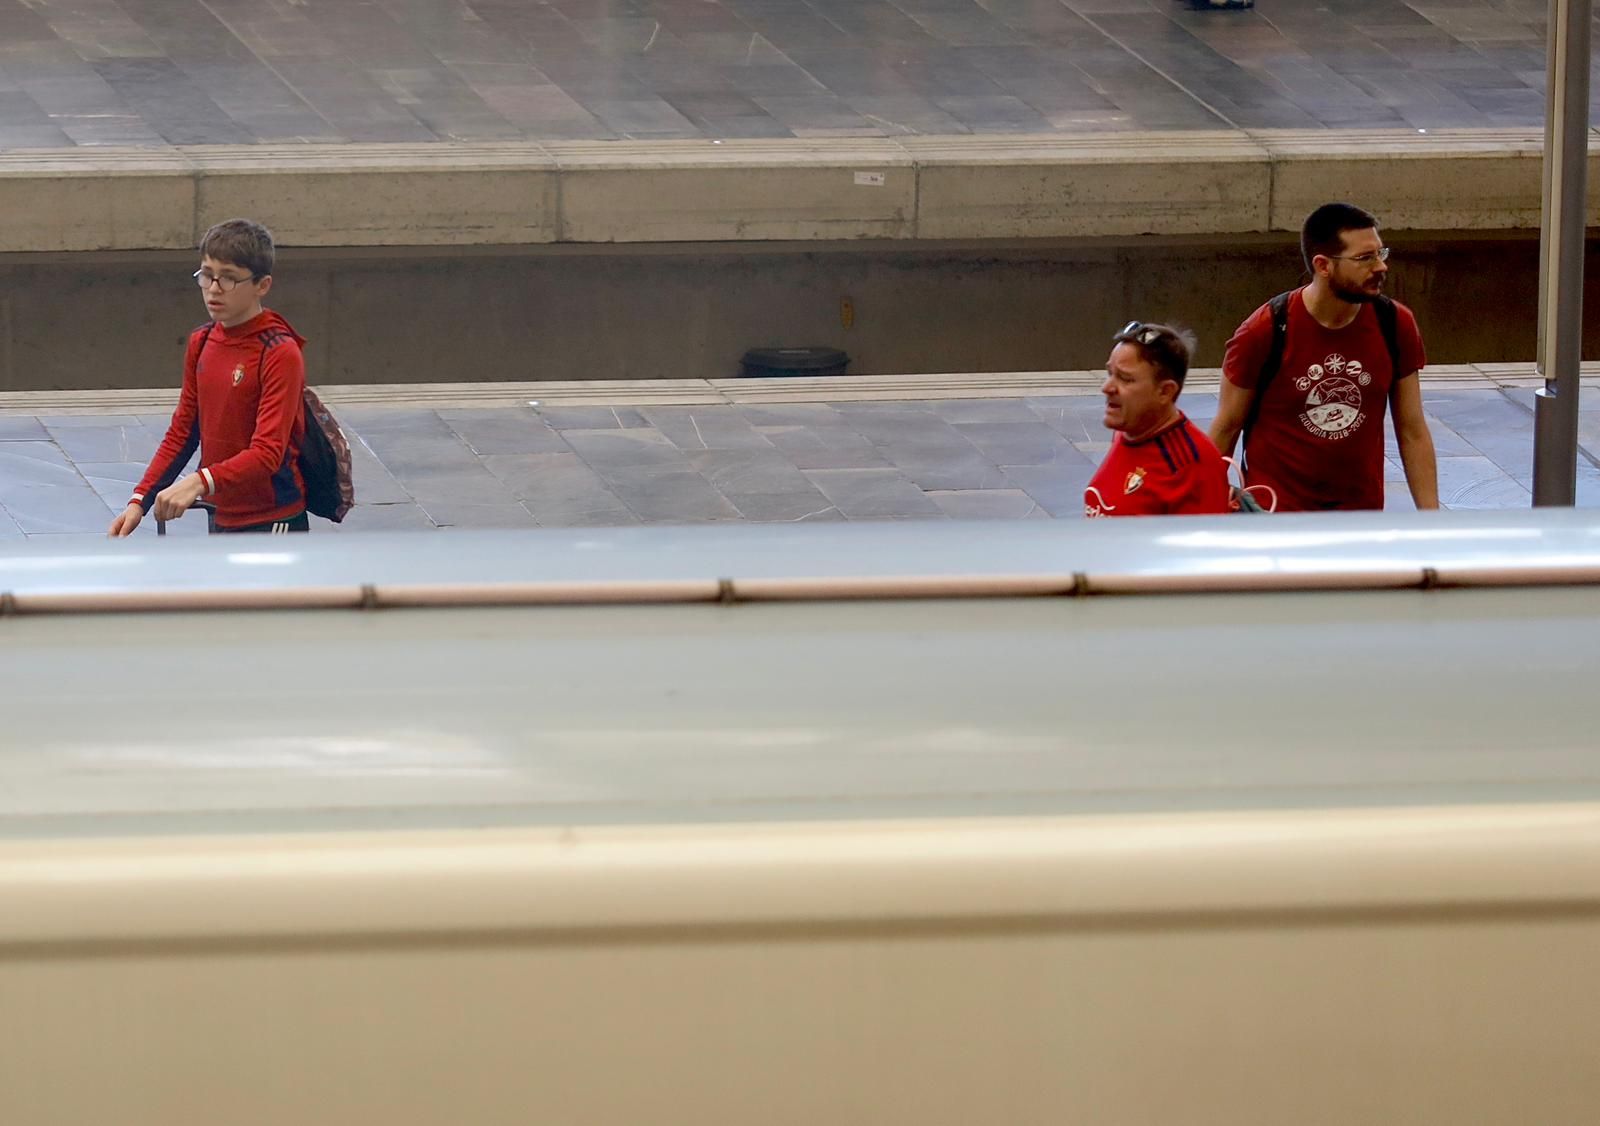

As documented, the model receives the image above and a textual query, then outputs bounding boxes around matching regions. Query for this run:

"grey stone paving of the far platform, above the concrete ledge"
[0,0,1580,149]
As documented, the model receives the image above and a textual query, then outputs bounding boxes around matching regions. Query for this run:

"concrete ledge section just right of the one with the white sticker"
[901,133,1270,238]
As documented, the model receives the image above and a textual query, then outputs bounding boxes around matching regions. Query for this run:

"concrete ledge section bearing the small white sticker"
[546,141,917,243]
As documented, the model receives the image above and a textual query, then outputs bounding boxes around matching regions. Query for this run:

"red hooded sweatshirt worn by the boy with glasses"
[133,309,306,528]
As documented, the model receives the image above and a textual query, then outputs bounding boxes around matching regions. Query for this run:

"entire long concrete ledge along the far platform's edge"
[0,130,1600,253]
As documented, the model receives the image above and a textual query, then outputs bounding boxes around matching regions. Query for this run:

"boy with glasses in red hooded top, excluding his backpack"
[110,219,307,536]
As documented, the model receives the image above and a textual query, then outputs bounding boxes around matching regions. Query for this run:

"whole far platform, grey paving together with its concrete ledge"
[0,0,1600,253]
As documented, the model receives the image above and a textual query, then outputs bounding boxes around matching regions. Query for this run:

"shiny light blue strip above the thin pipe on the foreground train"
[9,510,1600,595]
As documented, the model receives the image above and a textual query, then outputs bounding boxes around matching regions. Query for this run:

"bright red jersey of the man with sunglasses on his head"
[1083,413,1229,517]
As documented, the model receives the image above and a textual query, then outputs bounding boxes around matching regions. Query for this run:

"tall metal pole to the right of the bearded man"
[1533,0,1592,505]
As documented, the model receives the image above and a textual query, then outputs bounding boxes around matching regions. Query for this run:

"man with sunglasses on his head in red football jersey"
[1083,321,1229,517]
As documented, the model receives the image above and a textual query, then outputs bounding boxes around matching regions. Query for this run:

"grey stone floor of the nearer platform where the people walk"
[0,389,1600,539]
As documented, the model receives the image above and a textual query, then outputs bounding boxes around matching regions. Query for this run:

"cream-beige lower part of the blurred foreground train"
[0,806,1600,1126]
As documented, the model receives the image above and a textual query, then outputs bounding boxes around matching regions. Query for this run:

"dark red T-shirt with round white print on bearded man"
[1222,289,1427,512]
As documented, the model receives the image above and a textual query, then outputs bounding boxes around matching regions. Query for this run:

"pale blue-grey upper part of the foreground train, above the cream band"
[0,510,1600,837]
